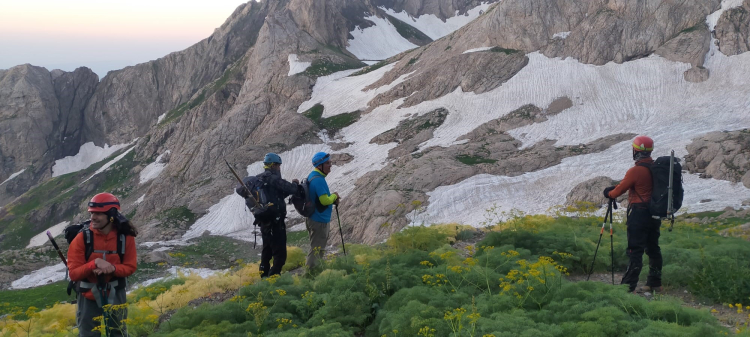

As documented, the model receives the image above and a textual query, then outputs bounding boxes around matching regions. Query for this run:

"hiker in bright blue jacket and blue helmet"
[305,152,341,271]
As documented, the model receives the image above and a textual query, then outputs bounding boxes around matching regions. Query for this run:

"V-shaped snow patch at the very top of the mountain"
[380,3,500,40]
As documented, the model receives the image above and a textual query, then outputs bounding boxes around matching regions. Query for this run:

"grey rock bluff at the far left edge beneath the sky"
[0,64,99,206]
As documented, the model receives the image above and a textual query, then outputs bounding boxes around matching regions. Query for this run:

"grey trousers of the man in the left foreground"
[76,288,128,337]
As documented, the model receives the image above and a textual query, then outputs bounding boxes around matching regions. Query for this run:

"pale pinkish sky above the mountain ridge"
[0,0,253,79]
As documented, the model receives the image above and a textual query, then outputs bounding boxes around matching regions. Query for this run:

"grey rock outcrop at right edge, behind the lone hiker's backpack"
[683,130,750,188]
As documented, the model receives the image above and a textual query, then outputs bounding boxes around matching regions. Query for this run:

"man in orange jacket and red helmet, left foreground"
[68,193,138,336]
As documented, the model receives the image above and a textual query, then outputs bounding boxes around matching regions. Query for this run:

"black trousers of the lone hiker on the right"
[621,204,662,292]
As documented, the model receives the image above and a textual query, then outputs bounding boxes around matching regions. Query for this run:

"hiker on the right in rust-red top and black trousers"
[604,136,662,292]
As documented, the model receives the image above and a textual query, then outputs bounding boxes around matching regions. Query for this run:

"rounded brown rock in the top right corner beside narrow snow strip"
[714,0,750,56]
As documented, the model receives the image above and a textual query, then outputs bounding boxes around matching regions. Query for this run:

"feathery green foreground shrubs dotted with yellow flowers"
[0,209,750,337]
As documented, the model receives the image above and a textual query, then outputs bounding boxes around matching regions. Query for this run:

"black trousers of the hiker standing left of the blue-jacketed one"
[260,218,286,277]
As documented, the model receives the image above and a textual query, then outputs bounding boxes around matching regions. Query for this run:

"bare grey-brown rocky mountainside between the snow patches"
[0,0,750,260]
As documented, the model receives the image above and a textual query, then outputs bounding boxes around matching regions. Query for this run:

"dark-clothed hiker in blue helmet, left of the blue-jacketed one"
[237,153,299,277]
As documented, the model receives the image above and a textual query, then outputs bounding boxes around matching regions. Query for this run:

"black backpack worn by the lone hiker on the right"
[638,156,684,218]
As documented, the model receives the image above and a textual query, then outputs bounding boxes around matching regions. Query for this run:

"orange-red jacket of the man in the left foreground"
[68,228,138,300]
